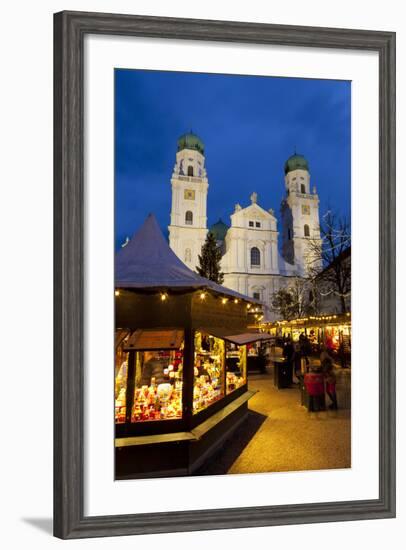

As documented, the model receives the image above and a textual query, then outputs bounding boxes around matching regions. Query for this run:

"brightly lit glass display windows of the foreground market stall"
[115,329,252,437]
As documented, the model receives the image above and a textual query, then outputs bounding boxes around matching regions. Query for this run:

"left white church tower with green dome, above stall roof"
[168,132,209,270]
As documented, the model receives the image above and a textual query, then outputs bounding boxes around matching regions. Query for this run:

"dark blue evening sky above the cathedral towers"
[115,69,351,247]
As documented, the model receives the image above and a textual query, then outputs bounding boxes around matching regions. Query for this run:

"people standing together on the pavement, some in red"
[283,333,338,410]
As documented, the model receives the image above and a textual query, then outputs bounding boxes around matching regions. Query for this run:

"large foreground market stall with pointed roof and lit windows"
[115,215,270,478]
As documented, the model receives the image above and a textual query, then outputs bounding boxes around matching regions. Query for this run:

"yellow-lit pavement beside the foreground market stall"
[196,367,351,475]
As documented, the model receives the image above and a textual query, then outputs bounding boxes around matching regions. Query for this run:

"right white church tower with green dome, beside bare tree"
[281,153,321,276]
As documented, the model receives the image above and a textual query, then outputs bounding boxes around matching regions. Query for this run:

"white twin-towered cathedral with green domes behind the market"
[169,132,321,306]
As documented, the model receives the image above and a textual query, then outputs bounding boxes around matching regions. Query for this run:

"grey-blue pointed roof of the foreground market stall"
[115,214,261,303]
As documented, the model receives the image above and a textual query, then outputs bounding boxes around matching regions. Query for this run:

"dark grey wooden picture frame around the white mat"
[54,8,395,538]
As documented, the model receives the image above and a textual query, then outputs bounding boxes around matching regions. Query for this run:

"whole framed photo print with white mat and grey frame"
[54,12,395,538]
